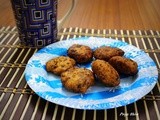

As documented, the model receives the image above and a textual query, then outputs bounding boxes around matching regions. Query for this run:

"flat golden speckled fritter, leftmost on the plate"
[46,56,76,75]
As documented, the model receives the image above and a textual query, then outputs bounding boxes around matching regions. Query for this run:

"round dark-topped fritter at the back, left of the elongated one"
[68,44,93,63]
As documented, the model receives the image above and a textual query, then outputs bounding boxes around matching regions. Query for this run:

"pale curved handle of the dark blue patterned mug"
[57,0,77,32]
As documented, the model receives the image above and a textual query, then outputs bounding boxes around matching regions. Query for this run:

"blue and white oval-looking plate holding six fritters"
[25,37,158,109]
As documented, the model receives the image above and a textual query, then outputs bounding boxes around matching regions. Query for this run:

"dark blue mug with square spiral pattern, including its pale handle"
[11,0,75,47]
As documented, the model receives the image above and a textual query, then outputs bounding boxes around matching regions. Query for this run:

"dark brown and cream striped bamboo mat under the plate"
[0,27,160,120]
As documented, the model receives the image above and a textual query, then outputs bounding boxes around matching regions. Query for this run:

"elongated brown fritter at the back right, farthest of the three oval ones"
[93,46,124,61]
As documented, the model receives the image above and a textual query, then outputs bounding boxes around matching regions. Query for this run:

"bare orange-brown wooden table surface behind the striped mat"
[0,0,160,30]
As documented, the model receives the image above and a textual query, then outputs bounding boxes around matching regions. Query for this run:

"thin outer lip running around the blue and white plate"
[25,37,158,110]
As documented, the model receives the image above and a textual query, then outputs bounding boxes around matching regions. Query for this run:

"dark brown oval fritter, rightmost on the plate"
[108,56,138,75]
